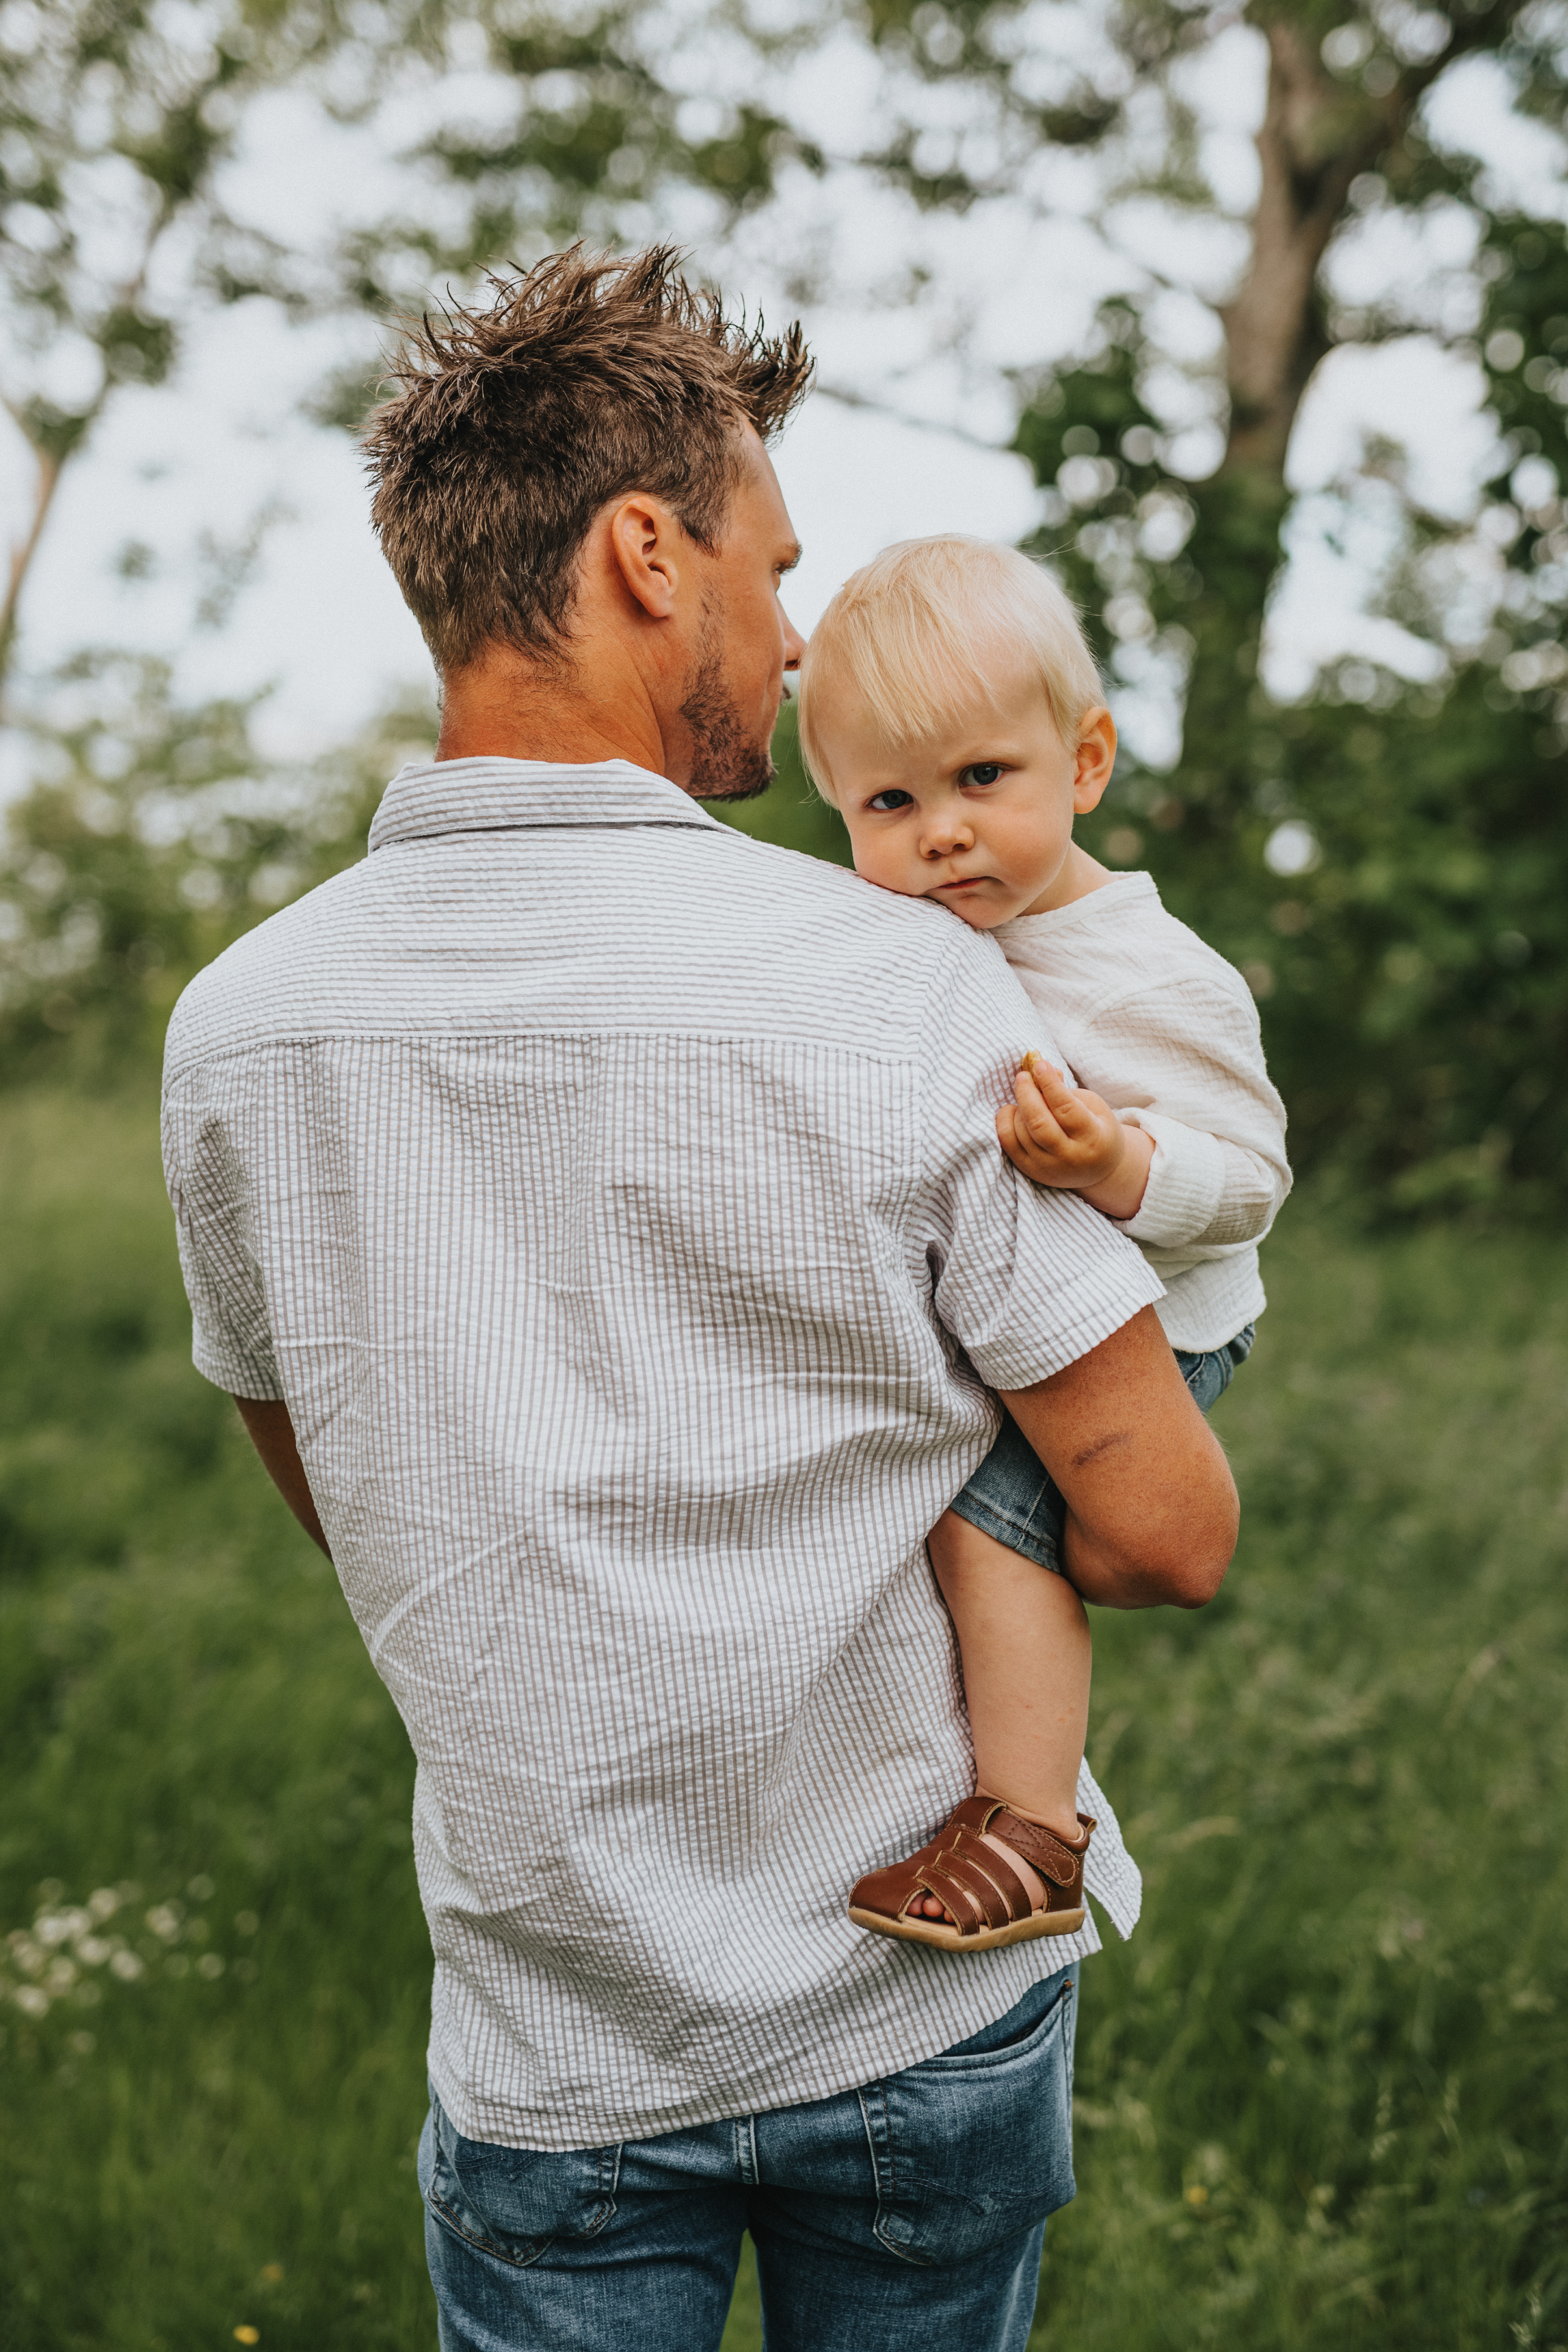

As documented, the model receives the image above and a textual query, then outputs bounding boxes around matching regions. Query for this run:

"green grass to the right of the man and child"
[1039,1206,1568,2352]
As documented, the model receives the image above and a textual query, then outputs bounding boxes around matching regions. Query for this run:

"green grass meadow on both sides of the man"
[0,1094,1568,2352]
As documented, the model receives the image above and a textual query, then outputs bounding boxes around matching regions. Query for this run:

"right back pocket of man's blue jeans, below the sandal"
[861,1981,1077,2265]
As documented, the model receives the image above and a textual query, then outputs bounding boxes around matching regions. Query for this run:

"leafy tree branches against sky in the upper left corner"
[0,0,832,694]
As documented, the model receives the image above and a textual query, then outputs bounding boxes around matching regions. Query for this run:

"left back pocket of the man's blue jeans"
[418,2100,621,2270]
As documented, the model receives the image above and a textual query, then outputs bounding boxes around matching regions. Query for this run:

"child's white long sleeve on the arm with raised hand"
[1077,974,1290,1249]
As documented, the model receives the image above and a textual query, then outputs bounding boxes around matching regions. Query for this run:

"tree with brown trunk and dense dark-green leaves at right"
[982,7,1568,1206]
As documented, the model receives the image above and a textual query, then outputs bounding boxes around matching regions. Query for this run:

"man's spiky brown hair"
[364,245,811,673]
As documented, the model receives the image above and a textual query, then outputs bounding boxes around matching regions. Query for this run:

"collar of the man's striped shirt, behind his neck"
[369,760,717,849]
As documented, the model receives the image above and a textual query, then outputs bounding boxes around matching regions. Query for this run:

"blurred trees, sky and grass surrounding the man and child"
[0,0,1568,2352]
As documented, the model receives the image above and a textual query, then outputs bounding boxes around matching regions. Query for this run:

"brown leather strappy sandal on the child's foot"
[849,1797,1095,1952]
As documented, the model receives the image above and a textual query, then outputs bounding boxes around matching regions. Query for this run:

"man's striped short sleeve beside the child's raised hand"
[917,934,1164,1388]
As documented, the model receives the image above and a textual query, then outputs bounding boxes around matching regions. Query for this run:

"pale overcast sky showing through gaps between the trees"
[0,16,1561,790]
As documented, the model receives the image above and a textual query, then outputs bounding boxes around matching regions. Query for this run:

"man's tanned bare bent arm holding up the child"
[1001,1308,1239,1609]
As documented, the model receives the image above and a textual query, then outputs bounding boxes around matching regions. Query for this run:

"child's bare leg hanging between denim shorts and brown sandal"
[922,1510,1093,1917]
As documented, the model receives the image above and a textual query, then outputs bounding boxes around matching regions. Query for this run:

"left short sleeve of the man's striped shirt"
[162,1087,282,1400]
